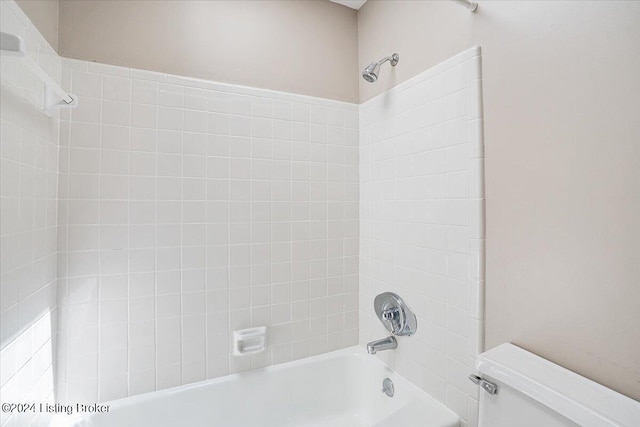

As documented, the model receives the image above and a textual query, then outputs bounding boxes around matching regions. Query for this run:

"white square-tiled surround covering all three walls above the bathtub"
[0,0,484,426]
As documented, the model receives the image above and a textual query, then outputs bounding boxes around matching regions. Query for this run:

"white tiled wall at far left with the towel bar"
[0,0,61,426]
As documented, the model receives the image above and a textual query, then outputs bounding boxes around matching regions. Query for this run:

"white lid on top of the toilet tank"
[476,343,640,426]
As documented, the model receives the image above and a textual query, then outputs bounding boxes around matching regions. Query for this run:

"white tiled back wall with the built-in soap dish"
[59,60,359,401]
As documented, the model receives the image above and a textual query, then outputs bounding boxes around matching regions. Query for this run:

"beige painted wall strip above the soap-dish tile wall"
[59,0,358,102]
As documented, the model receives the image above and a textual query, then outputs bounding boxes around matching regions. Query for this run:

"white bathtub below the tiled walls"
[55,346,459,427]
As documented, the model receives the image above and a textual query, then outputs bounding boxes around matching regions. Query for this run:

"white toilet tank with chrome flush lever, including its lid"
[476,344,640,427]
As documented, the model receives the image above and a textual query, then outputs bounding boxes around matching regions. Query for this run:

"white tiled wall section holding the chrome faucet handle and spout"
[359,48,484,425]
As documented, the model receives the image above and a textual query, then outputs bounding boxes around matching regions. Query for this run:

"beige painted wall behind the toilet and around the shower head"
[358,1,640,400]
